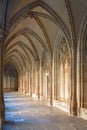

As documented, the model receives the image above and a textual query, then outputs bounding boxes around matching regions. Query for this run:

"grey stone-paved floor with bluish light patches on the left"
[3,92,87,130]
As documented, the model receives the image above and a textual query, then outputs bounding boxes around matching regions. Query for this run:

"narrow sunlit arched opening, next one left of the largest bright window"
[41,51,50,100]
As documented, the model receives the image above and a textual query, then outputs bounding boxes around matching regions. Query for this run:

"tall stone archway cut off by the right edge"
[77,13,87,119]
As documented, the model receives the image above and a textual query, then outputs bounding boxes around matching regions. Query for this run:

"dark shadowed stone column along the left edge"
[0,29,7,129]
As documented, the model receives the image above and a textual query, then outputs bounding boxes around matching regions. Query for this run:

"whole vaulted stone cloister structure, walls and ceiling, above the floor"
[0,0,87,126]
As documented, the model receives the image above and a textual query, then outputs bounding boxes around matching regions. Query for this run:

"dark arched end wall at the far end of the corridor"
[3,64,18,92]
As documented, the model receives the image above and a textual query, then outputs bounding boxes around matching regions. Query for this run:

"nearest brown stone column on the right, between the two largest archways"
[70,48,77,116]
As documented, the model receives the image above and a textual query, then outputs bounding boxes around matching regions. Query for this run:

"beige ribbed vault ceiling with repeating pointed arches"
[1,0,87,73]
